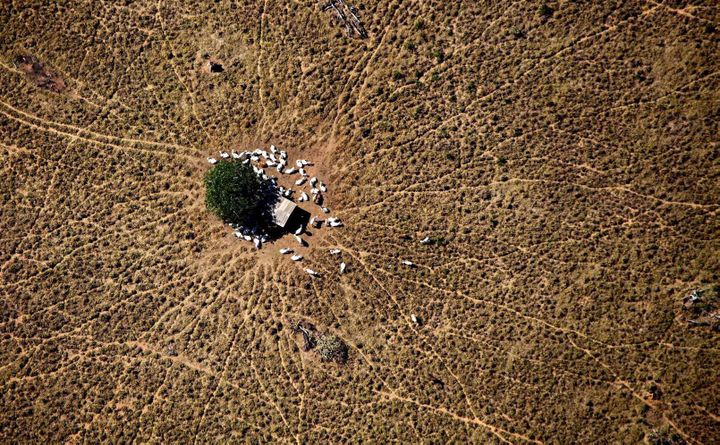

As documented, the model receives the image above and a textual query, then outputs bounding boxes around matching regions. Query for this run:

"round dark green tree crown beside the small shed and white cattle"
[205,162,263,224]
